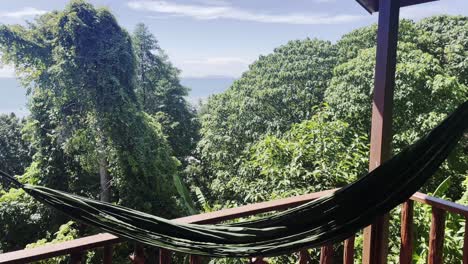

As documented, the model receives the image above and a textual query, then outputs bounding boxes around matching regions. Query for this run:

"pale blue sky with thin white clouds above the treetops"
[0,0,468,112]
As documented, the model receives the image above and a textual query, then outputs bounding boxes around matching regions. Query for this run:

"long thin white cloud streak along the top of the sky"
[127,0,364,25]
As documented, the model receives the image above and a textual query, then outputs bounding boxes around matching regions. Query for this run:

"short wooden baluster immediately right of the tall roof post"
[400,200,414,264]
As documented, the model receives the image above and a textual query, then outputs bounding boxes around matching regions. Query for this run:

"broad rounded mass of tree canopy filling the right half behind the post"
[194,16,468,206]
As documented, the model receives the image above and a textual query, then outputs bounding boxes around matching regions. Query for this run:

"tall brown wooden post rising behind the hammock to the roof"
[362,0,400,264]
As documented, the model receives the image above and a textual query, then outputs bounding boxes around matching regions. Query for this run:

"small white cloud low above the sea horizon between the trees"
[174,57,253,78]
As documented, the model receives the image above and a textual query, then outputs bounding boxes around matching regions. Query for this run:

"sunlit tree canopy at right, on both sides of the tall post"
[325,16,468,196]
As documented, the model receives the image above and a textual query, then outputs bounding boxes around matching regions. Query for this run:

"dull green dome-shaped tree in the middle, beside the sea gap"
[196,39,336,199]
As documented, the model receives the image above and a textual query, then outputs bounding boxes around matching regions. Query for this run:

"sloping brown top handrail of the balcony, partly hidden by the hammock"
[0,189,468,264]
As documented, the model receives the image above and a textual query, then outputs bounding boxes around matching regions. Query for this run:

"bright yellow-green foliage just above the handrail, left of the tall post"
[218,110,368,203]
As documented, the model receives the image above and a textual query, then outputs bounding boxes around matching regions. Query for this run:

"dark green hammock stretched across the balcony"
[4,101,468,257]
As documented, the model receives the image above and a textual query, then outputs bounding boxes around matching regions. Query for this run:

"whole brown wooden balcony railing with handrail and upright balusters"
[0,190,468,264]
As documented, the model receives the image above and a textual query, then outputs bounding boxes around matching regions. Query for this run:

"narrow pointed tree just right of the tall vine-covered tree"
[132,23,198,162]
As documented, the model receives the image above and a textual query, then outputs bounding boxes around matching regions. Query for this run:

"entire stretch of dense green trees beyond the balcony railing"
[0,1,468,263]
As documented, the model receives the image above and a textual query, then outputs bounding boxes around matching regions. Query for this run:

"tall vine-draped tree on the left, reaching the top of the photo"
[0,1,183,253]
